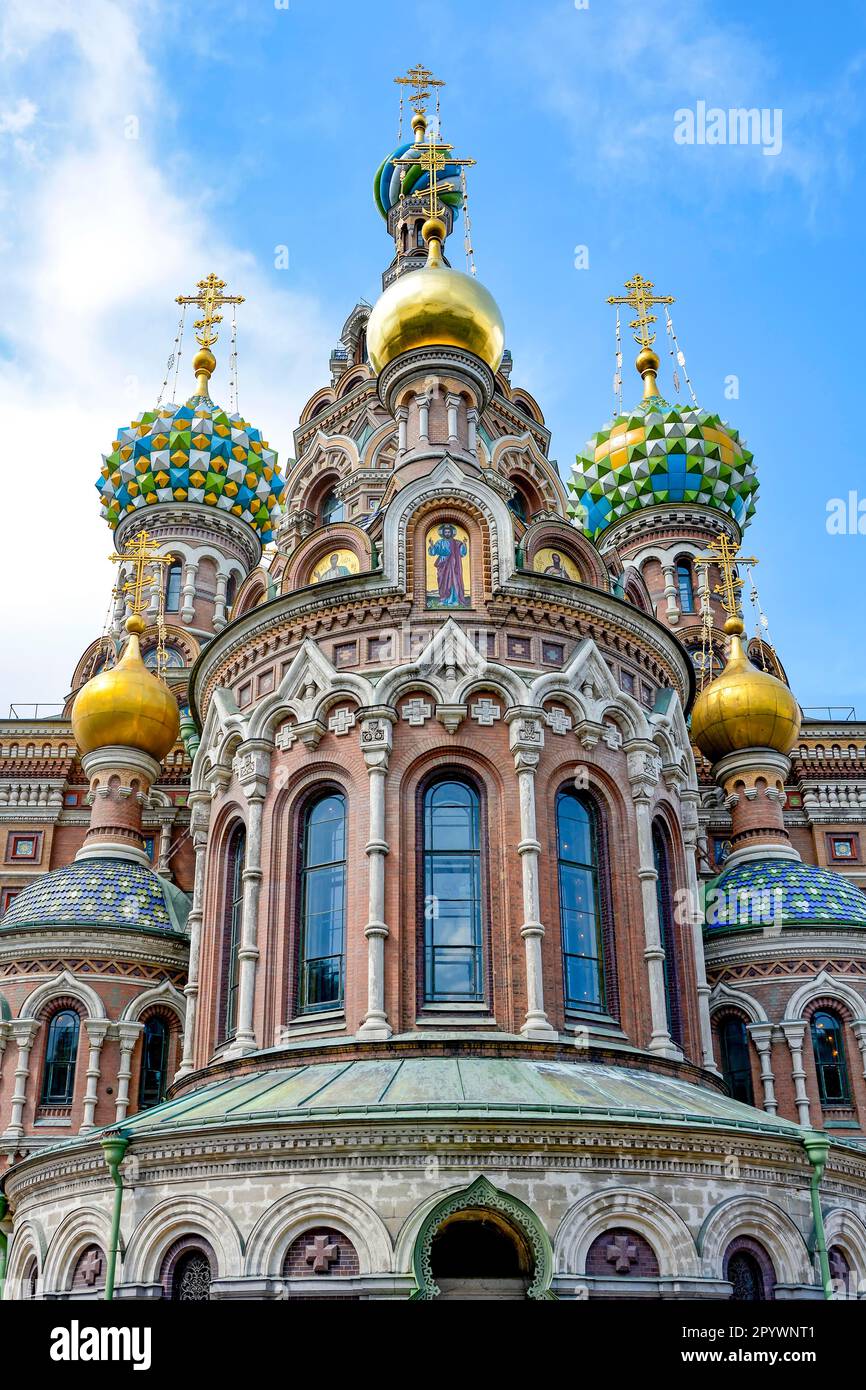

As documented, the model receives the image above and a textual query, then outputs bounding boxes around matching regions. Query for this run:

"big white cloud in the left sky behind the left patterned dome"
[0,0,332,716]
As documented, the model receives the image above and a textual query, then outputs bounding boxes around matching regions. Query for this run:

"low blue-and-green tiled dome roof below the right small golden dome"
[706,859,866,933]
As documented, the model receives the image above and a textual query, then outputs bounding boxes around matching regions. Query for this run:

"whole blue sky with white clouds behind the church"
[0,0,866,716]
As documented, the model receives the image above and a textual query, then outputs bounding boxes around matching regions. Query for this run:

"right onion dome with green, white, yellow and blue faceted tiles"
[569,395,758,539]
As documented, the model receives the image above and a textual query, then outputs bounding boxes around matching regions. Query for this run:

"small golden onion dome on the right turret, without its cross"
[691,617,799,763]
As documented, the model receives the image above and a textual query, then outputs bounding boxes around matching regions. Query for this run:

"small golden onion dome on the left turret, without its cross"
[72,613,179,762]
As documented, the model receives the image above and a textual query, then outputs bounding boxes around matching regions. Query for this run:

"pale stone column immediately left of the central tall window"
[357,708,396,1038]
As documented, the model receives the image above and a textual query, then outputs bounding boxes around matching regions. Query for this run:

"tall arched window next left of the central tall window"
[297,792,346,1012]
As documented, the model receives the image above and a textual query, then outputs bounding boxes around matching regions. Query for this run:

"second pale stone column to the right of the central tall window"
[624,738,683,1058]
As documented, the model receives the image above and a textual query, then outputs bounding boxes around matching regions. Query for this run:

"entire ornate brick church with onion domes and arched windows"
[0,78,866,1301]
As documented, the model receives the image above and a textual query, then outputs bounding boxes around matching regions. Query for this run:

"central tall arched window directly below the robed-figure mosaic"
[423,777,484,1004]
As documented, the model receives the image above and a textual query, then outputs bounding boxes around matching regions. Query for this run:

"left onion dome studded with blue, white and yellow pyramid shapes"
[96,366,285,541]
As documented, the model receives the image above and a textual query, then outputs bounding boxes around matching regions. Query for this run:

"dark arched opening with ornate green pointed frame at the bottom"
[411,1177,553,1300]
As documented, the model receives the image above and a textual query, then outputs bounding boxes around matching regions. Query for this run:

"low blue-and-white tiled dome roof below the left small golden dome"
[0,859,189,931]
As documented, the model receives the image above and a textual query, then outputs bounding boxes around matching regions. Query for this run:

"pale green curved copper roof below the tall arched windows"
[86,1056,799,1140]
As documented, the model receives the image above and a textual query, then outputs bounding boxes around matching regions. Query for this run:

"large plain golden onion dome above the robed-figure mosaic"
[367,218,505,373]
